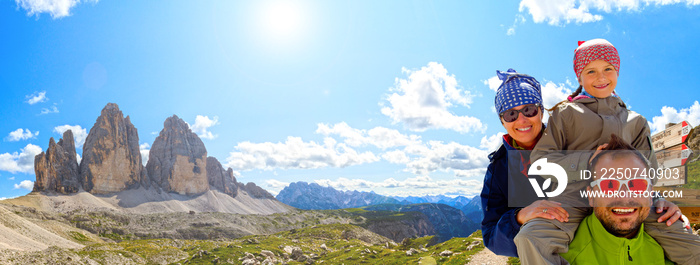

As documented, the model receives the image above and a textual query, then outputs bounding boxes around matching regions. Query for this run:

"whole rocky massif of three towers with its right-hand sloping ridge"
[34,103,278,212]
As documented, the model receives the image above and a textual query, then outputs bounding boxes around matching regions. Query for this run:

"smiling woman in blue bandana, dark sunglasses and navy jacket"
[481,69,568,257]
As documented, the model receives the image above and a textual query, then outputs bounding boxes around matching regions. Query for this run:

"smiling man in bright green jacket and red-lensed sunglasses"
[561,135,688,264]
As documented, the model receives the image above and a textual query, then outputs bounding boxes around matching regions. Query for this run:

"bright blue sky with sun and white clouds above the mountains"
[0,0,700,198]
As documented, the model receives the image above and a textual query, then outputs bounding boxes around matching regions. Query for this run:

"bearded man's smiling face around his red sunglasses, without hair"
[588,154,651,238]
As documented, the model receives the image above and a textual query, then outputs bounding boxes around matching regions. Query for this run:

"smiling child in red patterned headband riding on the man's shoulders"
[514,39,700,264]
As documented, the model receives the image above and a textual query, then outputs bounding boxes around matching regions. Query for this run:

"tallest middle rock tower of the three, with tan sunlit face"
[80,103,145,194]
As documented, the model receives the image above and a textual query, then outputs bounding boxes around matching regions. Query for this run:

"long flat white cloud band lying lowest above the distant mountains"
[314,174,483,196]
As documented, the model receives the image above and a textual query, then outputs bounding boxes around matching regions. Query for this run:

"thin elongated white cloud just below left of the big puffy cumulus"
[316,122,420,149]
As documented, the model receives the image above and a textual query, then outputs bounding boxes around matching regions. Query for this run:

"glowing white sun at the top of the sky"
[261,0,304,42]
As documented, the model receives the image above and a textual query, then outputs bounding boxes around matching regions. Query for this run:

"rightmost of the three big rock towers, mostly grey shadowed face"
[146,115,209,195]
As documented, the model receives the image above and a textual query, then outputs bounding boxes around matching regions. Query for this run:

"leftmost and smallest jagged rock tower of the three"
[33,130,81,193]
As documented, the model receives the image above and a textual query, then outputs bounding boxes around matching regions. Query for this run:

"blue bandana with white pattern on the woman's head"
[496,69,542,114]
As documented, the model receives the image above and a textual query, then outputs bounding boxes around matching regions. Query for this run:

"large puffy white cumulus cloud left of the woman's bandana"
[380,62,486,133]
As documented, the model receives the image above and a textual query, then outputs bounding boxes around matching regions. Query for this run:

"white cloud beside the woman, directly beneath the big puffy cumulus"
[405,141,489,175]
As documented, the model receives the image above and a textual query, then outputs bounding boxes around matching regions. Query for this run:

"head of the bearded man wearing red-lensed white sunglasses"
[588,134,651,238]
